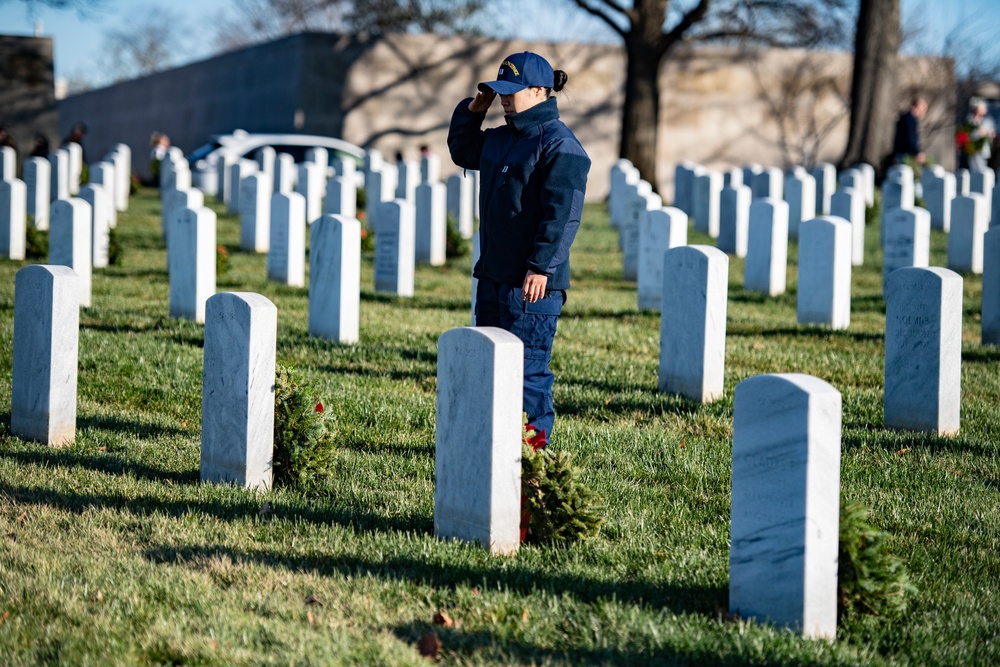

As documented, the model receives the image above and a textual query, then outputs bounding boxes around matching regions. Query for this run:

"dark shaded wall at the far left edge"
[0,35,61,172]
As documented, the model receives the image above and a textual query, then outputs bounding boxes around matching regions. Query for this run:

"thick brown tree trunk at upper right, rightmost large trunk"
[840,0,900,169]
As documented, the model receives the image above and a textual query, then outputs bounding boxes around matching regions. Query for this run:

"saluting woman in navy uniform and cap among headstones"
[448,51,590,439]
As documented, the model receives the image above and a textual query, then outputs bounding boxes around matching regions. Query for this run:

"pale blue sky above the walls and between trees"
[0,0,1000,79]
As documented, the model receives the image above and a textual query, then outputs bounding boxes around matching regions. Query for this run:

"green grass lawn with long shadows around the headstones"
[0,190,1000,665]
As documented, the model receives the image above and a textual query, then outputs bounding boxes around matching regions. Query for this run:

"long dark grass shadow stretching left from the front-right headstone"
[146,545,728,614]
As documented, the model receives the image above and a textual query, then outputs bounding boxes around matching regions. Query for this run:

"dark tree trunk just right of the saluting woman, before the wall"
[620,40,660,190]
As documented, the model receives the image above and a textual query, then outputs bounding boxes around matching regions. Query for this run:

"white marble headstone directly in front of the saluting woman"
[434,327,524,554]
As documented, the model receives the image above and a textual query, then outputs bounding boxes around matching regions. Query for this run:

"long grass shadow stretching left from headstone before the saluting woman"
[0,482,434,535]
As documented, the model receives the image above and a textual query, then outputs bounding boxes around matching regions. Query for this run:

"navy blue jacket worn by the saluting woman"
[448,97,590,290]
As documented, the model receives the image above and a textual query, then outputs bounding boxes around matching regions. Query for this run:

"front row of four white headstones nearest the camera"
[5,268,836,637]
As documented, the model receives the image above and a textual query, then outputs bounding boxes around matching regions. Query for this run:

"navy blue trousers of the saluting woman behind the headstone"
[476,278,566,440]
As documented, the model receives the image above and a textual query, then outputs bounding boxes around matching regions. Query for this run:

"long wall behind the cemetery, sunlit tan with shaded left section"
[61,33,954,199]
